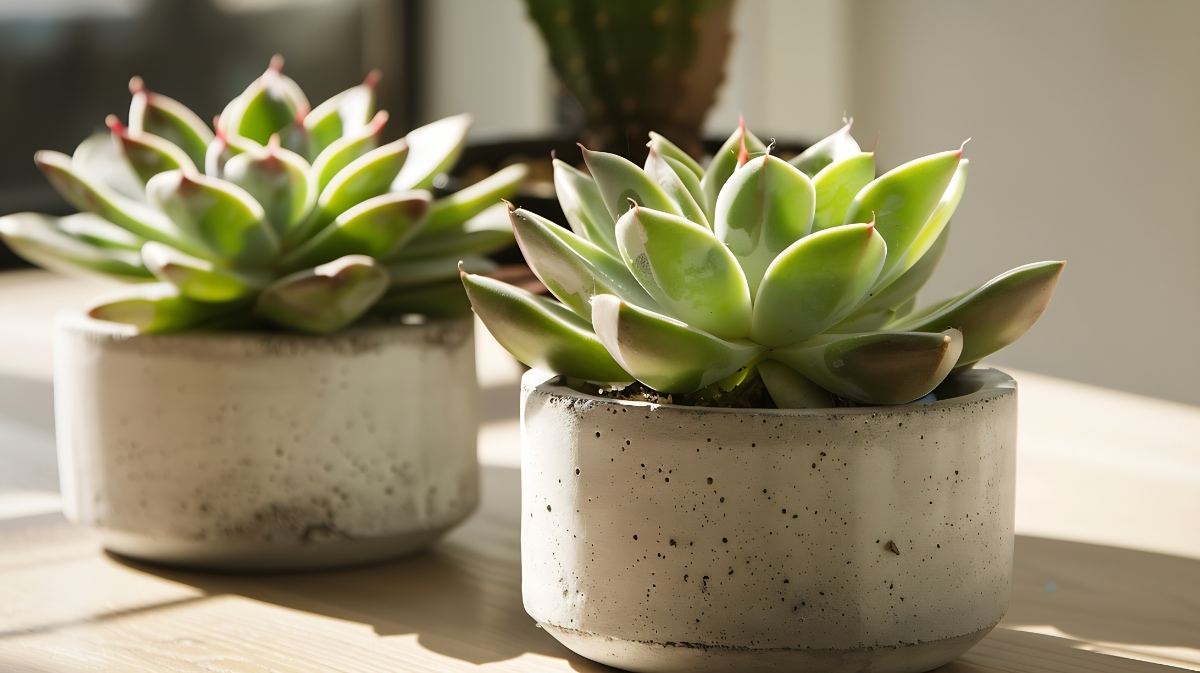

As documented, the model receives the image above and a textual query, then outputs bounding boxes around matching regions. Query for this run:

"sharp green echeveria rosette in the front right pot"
[462,124,1063,407]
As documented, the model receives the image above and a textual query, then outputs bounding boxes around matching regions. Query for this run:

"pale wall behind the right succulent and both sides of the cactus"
[426,0,1200,404]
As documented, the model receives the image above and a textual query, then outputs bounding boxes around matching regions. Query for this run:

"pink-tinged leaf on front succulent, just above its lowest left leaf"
[509,203,654,319]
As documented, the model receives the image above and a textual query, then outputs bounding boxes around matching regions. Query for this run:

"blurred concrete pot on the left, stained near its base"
[54,314,479,570]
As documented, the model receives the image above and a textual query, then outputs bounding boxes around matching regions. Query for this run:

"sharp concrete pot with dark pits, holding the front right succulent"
[521,369,1016,673]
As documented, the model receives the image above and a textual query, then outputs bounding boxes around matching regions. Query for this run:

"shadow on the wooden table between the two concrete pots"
[113,465,613,672]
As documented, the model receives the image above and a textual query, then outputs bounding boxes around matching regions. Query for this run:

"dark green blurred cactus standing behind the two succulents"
[526,0,733,161]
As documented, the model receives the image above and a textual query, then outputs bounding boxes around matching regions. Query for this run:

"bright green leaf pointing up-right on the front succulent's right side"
[846,149,962,288]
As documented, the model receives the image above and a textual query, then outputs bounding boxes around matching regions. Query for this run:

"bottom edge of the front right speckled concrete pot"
[538,621,995,673]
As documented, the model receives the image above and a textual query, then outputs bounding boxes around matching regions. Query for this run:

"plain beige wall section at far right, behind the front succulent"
[851,0,1200,403]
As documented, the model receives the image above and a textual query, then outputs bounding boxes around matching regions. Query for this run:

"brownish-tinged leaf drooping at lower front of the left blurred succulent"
[254,254,388,334]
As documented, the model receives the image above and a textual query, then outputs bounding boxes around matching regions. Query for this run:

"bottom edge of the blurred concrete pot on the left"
[101,525,454,572]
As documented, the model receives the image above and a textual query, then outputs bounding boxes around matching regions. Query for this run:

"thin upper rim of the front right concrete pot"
[521,367,1016,416]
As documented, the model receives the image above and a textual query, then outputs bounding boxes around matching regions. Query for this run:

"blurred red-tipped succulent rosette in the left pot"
[0,56,524,332]
